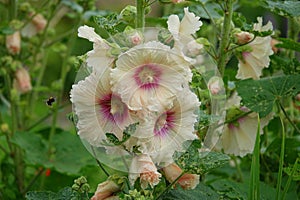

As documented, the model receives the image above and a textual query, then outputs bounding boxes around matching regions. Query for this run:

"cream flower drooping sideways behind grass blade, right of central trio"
[219,93,272,157]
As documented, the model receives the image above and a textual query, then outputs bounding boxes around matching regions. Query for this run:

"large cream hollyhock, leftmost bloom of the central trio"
[71,68,132,146]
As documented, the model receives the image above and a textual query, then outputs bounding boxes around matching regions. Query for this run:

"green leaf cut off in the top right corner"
[262,0,300,17]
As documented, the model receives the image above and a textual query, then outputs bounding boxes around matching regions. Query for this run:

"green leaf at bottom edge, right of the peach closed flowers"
[159,183,220,200]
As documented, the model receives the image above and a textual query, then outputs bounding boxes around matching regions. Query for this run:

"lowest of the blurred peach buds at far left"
[14,67,32,94]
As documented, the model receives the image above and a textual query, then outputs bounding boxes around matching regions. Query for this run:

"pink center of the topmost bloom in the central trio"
[133,64,162,90]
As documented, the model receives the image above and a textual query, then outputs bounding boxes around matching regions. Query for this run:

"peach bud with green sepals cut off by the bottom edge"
[91,180,120,200]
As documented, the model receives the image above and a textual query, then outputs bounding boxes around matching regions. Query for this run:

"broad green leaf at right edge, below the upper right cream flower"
[236,74,300,118]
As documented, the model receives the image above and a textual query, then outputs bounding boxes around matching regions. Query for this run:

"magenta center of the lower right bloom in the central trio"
[154,111,175,136]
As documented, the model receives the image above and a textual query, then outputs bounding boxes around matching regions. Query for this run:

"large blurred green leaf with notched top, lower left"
[12,132,96,175]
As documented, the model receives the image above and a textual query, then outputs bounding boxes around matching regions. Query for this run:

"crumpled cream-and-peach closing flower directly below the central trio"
[129,154,161,189]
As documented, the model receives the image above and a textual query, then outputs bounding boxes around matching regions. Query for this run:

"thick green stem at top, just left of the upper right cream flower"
[218,0,234,76]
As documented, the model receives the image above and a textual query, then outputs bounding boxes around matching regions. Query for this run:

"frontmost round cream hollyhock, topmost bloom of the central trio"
[111,41,192,111]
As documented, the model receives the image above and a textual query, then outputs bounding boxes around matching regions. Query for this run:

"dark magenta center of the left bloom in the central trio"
[98,93,128,123]
